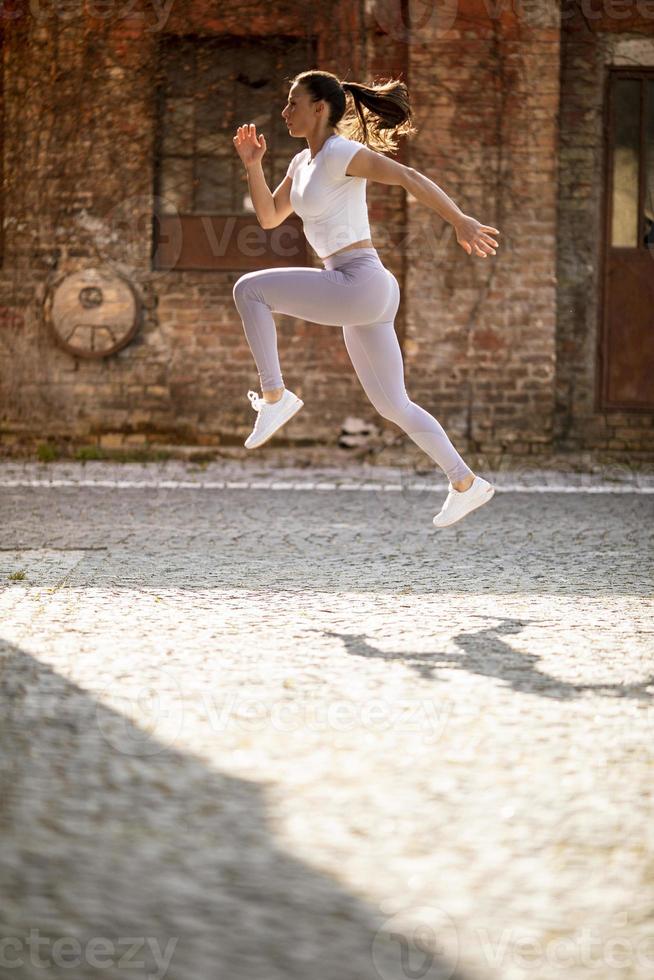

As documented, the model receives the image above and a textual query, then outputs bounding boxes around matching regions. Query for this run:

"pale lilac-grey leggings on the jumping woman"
[233,248,472,482]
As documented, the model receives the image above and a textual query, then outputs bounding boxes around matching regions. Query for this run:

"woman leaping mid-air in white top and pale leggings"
[233,70,500,527]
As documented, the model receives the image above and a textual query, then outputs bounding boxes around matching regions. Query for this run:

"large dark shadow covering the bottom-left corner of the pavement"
[0,643,480,980]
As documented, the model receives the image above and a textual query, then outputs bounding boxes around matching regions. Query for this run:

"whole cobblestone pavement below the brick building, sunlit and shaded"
[0,462,654,980]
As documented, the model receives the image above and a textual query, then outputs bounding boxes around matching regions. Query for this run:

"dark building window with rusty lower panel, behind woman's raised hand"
[153,35,316,270]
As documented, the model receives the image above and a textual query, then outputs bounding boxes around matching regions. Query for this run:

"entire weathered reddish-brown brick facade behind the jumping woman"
[0,0,654,460]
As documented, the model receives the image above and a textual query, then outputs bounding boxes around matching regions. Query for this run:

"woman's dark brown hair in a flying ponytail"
[293,69,418,152]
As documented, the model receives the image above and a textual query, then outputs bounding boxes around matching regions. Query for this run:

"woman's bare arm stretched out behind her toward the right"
[345,146,500,258]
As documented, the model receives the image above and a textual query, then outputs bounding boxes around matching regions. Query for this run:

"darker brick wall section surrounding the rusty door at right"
[555,9,654,453]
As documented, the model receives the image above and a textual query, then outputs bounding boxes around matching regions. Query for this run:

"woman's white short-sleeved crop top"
[286,133,371,258]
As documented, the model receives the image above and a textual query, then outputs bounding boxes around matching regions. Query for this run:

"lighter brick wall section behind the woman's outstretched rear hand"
[407,0,559,452]
